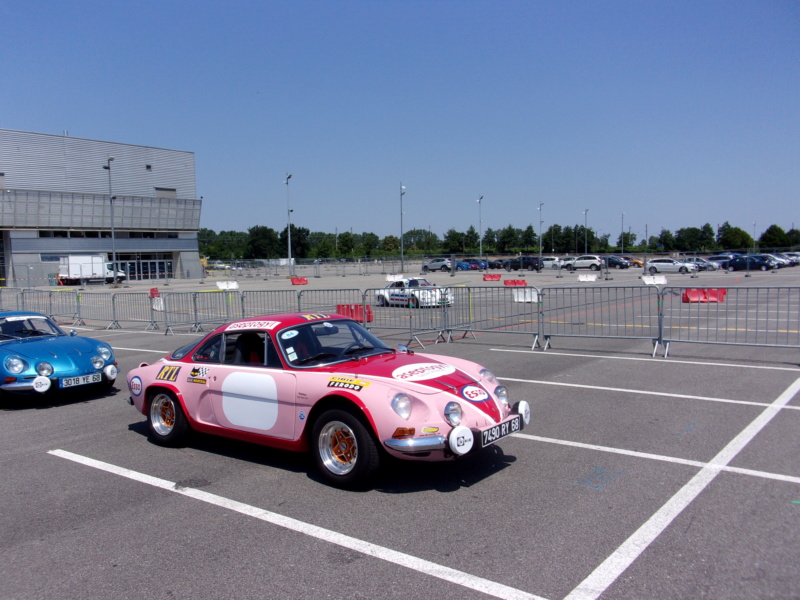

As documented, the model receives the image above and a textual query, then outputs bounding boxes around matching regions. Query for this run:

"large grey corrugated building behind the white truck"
[0,129,202,286]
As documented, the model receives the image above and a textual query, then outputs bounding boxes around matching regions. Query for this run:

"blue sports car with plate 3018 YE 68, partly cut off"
[0,311,118,394]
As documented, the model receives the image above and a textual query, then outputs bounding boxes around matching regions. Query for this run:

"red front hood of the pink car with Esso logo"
[324,353,502,421]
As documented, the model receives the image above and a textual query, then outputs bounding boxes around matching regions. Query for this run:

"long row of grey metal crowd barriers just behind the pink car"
[0,286,800,357]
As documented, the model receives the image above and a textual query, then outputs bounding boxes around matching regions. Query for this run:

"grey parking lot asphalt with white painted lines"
[0,269,800,600]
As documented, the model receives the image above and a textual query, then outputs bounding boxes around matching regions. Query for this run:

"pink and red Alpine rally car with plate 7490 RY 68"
[127,313,530,487]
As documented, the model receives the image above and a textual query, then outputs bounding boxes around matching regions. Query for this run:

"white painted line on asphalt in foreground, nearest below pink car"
[48,450,544,600]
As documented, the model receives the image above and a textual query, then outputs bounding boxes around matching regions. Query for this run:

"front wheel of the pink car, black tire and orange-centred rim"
[311,409,380,488]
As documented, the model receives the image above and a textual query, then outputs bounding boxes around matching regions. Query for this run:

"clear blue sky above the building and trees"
[0,0,800,242]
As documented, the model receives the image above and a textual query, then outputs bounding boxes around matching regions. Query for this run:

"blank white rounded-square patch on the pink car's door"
[222,373,278,431]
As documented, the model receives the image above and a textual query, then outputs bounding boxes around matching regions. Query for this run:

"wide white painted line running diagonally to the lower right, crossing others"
[564,379,800,600]
